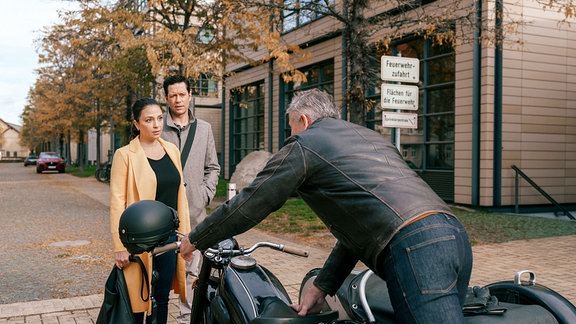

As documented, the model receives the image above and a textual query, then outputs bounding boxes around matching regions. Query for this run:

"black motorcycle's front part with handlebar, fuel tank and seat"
[190,238,338,324]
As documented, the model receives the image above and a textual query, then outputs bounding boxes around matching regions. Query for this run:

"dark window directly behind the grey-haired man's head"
[280,60,334,143]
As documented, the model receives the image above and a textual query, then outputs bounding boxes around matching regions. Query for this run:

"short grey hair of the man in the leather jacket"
[286,89,340,122]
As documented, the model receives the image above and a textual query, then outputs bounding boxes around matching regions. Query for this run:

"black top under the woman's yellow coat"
[148,154,180,210]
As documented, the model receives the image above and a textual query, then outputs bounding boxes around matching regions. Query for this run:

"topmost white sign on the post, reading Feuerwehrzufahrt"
[381,56,420,83]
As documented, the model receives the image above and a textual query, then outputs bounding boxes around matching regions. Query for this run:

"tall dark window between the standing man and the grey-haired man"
[231,82,264,167]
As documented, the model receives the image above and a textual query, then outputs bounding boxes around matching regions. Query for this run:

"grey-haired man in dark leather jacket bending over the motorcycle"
[181,89,472,323]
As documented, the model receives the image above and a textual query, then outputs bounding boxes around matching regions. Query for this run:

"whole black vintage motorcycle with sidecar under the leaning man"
[170,238,576,324]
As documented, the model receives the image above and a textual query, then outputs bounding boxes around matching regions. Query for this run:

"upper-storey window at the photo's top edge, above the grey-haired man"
[282,0,332,33]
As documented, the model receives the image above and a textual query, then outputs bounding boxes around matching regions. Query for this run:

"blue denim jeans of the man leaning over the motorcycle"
[376,214,472,324]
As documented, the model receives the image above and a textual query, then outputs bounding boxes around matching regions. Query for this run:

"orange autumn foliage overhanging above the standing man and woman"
[77,0,310,93]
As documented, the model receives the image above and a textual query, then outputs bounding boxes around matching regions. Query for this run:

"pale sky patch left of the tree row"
[0,0,75,125]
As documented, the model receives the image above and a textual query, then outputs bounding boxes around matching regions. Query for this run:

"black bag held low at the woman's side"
[96,265,134,324]
